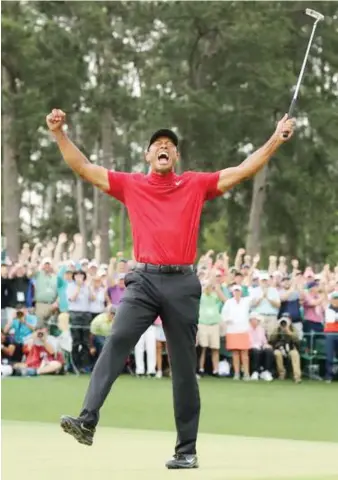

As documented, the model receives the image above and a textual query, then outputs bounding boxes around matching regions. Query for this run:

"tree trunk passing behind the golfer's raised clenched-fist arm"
[99,109,113,263]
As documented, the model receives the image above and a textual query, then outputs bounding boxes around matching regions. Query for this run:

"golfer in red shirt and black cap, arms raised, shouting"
[46,110,294,469]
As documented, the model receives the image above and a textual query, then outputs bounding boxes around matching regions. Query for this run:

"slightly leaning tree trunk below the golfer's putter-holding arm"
[246,165,268,255]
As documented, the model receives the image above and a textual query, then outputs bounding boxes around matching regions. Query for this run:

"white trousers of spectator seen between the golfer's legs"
[134,325,156,377]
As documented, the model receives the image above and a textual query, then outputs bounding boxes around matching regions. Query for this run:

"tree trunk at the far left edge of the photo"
[2,67,21,260]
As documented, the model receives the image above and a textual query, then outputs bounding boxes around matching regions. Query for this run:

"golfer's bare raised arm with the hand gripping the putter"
[217,115,294,192]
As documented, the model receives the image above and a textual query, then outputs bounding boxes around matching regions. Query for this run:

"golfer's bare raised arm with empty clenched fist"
[46,110,110,192]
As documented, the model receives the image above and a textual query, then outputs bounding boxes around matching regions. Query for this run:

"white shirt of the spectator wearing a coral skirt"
[222,297,252,333]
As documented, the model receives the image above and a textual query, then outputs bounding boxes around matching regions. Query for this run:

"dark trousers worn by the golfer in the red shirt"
[80,270,201,453]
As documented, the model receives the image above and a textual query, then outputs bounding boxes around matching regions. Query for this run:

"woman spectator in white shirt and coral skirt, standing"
[222,285,251,380]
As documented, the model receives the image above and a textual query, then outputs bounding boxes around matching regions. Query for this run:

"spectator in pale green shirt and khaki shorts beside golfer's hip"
[197,281,222,375]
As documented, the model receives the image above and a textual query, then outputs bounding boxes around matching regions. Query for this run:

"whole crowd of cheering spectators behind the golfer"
[1,233,338,383]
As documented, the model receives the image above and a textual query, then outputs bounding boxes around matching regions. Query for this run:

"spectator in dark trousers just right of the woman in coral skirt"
[249,312,274,382]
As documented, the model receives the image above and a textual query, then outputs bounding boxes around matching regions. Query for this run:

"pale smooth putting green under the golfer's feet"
[2,421,338,480]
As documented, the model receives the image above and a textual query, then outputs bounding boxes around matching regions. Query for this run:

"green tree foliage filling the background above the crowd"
[2,1,338,263]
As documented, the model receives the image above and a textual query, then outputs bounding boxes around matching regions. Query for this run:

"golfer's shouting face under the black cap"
[146,137,178,173]
